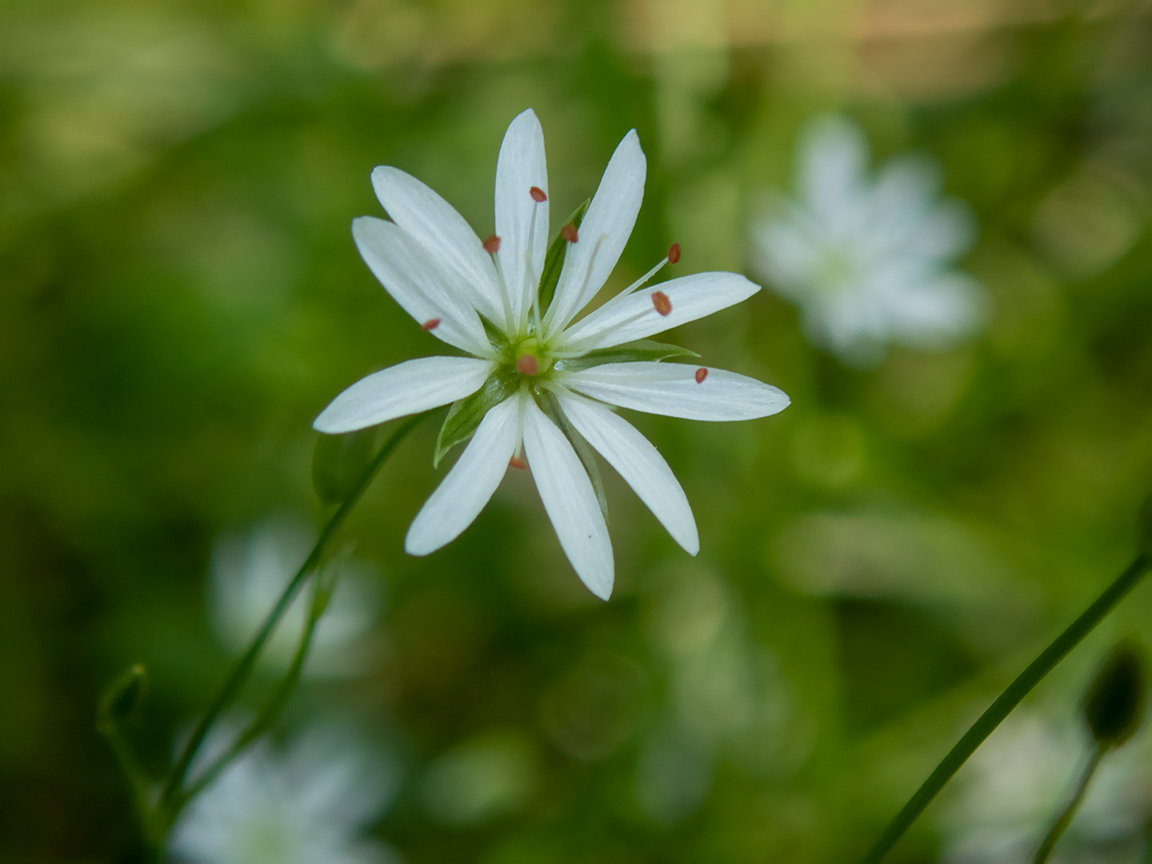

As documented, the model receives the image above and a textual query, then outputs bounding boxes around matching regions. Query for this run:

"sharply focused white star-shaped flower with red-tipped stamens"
[313,111,788,598]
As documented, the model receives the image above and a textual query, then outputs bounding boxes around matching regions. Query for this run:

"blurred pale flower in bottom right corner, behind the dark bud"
[940,714,1152,864]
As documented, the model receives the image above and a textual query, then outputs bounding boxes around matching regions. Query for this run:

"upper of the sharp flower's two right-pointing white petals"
[560,273,760,351]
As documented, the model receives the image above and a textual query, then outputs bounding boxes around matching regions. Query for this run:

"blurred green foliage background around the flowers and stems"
[0,0,1152,864]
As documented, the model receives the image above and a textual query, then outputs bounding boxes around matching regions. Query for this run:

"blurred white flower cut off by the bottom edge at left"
[168,727,395,864]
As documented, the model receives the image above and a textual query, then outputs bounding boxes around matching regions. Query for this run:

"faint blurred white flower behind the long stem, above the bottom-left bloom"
[209,517,380,676]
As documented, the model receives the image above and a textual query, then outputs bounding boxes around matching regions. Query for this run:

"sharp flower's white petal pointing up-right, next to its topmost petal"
[546,129,646,334]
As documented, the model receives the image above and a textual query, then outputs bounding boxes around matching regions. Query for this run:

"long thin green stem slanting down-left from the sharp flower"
[157,415,426,825]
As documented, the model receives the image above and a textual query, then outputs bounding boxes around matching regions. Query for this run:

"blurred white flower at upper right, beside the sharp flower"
[752,116,983,364]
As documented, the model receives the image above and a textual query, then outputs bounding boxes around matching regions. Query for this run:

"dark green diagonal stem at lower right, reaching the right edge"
[863,553,1149,864]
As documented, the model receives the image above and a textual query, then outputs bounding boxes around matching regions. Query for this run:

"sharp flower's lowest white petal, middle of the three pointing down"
[524,399,614,600]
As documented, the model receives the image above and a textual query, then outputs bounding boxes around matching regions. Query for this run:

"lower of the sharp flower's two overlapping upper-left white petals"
[353,217,492,355]
